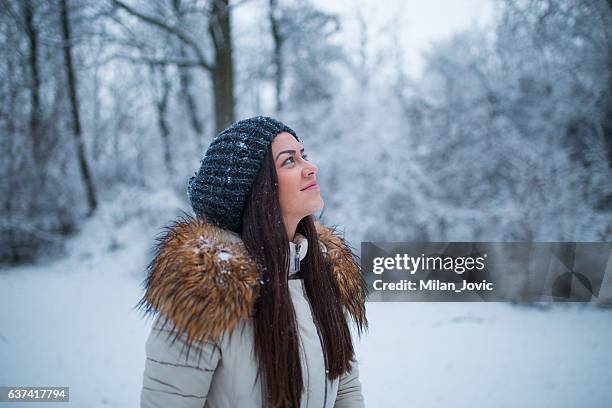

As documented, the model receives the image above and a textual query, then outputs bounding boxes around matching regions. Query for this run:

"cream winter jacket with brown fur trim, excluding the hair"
[138,217,367,408]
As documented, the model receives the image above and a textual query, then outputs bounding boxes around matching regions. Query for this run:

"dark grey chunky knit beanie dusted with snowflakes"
[187,116,300,233]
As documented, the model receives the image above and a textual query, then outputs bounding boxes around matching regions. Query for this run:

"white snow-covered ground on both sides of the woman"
[0,187,612,408]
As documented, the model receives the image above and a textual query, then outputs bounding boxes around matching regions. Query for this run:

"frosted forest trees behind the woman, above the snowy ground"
[0,0,612,263]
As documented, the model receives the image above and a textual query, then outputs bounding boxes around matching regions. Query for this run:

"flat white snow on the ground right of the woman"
[357,303,612,408]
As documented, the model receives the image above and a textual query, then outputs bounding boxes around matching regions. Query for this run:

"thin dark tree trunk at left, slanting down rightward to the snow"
[60,0,98,216]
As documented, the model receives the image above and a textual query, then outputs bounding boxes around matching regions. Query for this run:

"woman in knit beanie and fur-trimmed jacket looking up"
[137,116,367,408]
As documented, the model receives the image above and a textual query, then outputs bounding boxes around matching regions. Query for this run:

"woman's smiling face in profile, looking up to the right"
[272,132,323,221]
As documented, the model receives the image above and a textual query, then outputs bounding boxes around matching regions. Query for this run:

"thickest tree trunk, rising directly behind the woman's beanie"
[208,0,235,133]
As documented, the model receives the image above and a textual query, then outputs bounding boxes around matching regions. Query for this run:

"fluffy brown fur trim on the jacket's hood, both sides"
[135,215,367,345]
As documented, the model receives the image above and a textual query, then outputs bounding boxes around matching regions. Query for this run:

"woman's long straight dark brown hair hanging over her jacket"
[241,148,367,407]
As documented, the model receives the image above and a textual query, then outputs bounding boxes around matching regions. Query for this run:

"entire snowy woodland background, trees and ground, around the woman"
[0,0,612,407]
